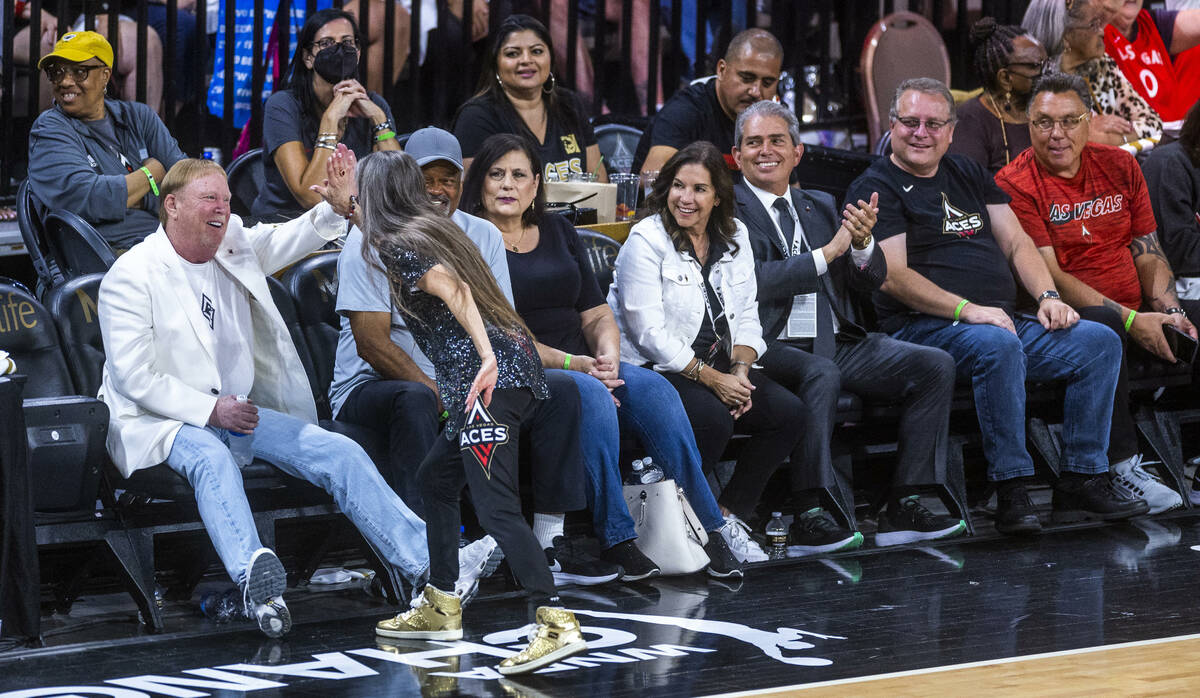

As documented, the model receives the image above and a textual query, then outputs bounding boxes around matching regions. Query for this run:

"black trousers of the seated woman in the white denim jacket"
[664,365,804,518]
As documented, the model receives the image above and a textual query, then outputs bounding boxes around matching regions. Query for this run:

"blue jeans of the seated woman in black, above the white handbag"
[566,361,725,548]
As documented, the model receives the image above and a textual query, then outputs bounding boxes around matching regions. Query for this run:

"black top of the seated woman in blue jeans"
[506,213,605,355]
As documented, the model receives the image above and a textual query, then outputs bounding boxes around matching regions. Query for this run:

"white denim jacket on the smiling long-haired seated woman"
[608,216,767,373]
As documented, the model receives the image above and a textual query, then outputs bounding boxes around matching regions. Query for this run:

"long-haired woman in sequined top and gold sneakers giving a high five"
[360,152,587,674]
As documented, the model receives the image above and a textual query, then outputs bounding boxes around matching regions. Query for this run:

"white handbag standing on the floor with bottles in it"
[624,480,708,574]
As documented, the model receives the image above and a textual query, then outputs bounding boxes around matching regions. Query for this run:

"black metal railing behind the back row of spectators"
[0,0,1027,197]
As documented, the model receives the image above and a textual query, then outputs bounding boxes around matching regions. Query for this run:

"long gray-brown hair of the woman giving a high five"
[358,151,532,336]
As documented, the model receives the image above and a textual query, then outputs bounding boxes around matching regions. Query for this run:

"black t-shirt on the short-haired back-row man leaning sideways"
[634,78,733,172]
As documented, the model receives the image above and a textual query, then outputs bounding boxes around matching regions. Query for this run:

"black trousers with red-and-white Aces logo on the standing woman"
[418,389,554,602]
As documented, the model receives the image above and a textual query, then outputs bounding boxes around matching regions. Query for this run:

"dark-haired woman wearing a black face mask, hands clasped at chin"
[251,10,400,221]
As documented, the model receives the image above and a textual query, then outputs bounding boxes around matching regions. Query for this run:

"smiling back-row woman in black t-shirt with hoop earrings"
[454,14,608,181]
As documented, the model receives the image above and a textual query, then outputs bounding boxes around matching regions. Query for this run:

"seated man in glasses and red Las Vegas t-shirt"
[996,73,1196,513]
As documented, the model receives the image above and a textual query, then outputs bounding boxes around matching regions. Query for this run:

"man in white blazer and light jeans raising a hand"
[98,146,494,637]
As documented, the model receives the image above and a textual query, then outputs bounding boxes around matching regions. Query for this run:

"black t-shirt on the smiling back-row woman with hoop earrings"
[454,89,596,182]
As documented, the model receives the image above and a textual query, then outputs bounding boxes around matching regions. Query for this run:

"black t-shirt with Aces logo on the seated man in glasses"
[846,155,1016,332]
